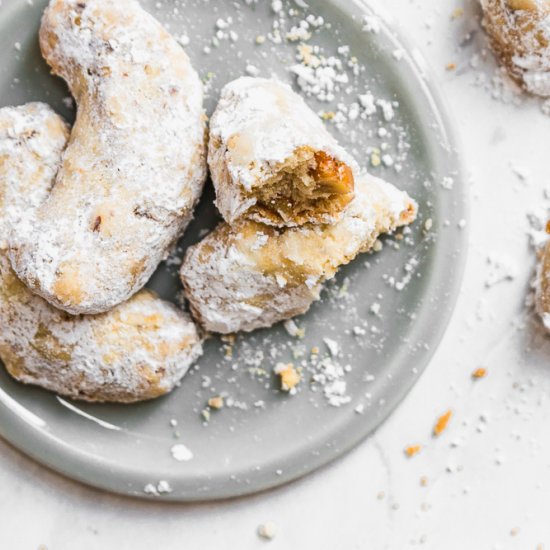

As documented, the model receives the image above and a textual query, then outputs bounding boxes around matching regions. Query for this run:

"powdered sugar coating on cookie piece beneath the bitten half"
[181,175,416,333]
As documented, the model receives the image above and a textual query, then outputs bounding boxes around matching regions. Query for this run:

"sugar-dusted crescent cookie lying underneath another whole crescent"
[0,103,202,403]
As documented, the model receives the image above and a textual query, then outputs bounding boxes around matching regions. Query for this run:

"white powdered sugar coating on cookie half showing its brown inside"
[208,77,358,223]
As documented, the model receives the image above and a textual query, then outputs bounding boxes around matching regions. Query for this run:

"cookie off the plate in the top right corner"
[480,0,550,97]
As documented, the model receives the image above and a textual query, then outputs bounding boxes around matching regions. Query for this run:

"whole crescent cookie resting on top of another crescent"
[10,0,206,314]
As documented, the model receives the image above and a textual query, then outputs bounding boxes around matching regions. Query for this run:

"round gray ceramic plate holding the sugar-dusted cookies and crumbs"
[0,0,466,501]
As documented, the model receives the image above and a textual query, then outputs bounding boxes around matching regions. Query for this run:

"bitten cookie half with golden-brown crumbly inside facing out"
[208,77,357,227]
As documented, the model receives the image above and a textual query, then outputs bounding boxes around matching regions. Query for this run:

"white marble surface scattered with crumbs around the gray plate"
[0,0,550,550]
